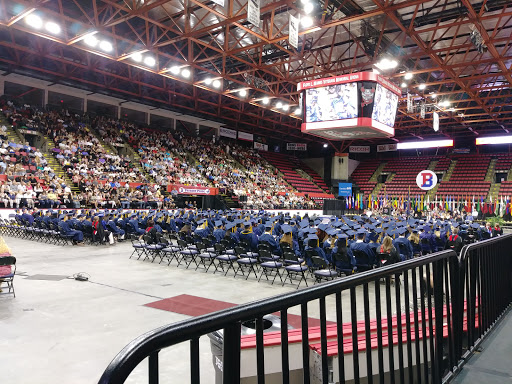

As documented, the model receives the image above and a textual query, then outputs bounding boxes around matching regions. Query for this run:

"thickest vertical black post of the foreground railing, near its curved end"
[222,321,242,384]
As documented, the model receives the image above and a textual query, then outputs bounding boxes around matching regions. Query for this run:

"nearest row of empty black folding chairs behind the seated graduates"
[130,234,352,288]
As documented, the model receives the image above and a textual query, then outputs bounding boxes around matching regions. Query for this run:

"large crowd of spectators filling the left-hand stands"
[0,100,315,209]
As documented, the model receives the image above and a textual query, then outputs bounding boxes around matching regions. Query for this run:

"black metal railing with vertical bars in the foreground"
[99,235,512,384]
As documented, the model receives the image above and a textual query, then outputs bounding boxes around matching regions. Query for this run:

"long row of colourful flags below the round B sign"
[346,193,512,216]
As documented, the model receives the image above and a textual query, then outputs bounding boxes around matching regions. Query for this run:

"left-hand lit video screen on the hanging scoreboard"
[306,83,358,123]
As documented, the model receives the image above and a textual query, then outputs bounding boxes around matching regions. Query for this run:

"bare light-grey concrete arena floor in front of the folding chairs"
[0,237,432,384]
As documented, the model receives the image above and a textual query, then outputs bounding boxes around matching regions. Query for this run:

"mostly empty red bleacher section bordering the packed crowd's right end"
[260,151,327,193]
